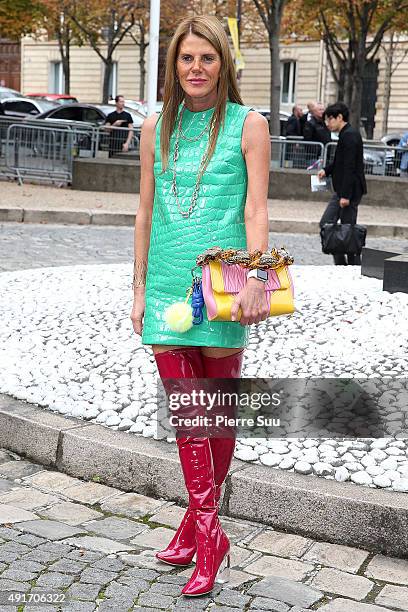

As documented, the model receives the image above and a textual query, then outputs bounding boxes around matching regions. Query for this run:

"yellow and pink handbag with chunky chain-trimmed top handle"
[196,247,295,321]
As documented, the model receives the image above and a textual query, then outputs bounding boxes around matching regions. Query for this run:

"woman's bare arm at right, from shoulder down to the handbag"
[242,112,271,251]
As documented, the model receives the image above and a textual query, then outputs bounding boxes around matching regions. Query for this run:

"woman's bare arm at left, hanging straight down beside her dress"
[133,113,157,295]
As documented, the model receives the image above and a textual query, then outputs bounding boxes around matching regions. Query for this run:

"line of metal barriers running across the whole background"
[0,117,403,183]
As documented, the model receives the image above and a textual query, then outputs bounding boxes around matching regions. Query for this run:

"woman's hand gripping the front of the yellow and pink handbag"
[231,278,269,325]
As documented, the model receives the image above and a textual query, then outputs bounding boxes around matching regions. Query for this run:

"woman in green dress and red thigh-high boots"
[131,15,270,595]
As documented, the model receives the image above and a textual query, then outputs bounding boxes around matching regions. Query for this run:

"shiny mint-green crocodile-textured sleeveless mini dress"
[142,101,252,348]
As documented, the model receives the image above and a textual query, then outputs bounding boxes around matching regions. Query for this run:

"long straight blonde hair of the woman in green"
[160,15,244,172]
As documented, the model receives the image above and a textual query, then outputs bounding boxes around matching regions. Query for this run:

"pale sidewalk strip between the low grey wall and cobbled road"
[0,182,408,238]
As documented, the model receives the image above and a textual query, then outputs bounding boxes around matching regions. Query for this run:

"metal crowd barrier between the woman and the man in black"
[271,136,324,170]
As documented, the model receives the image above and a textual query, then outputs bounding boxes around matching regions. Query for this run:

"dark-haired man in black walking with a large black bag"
[319,102,367,266]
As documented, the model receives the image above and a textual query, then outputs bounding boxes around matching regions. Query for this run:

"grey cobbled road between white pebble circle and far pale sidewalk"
[0,223,407,271]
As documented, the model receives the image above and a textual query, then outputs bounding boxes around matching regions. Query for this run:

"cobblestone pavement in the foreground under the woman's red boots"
[0,450,408,612]
